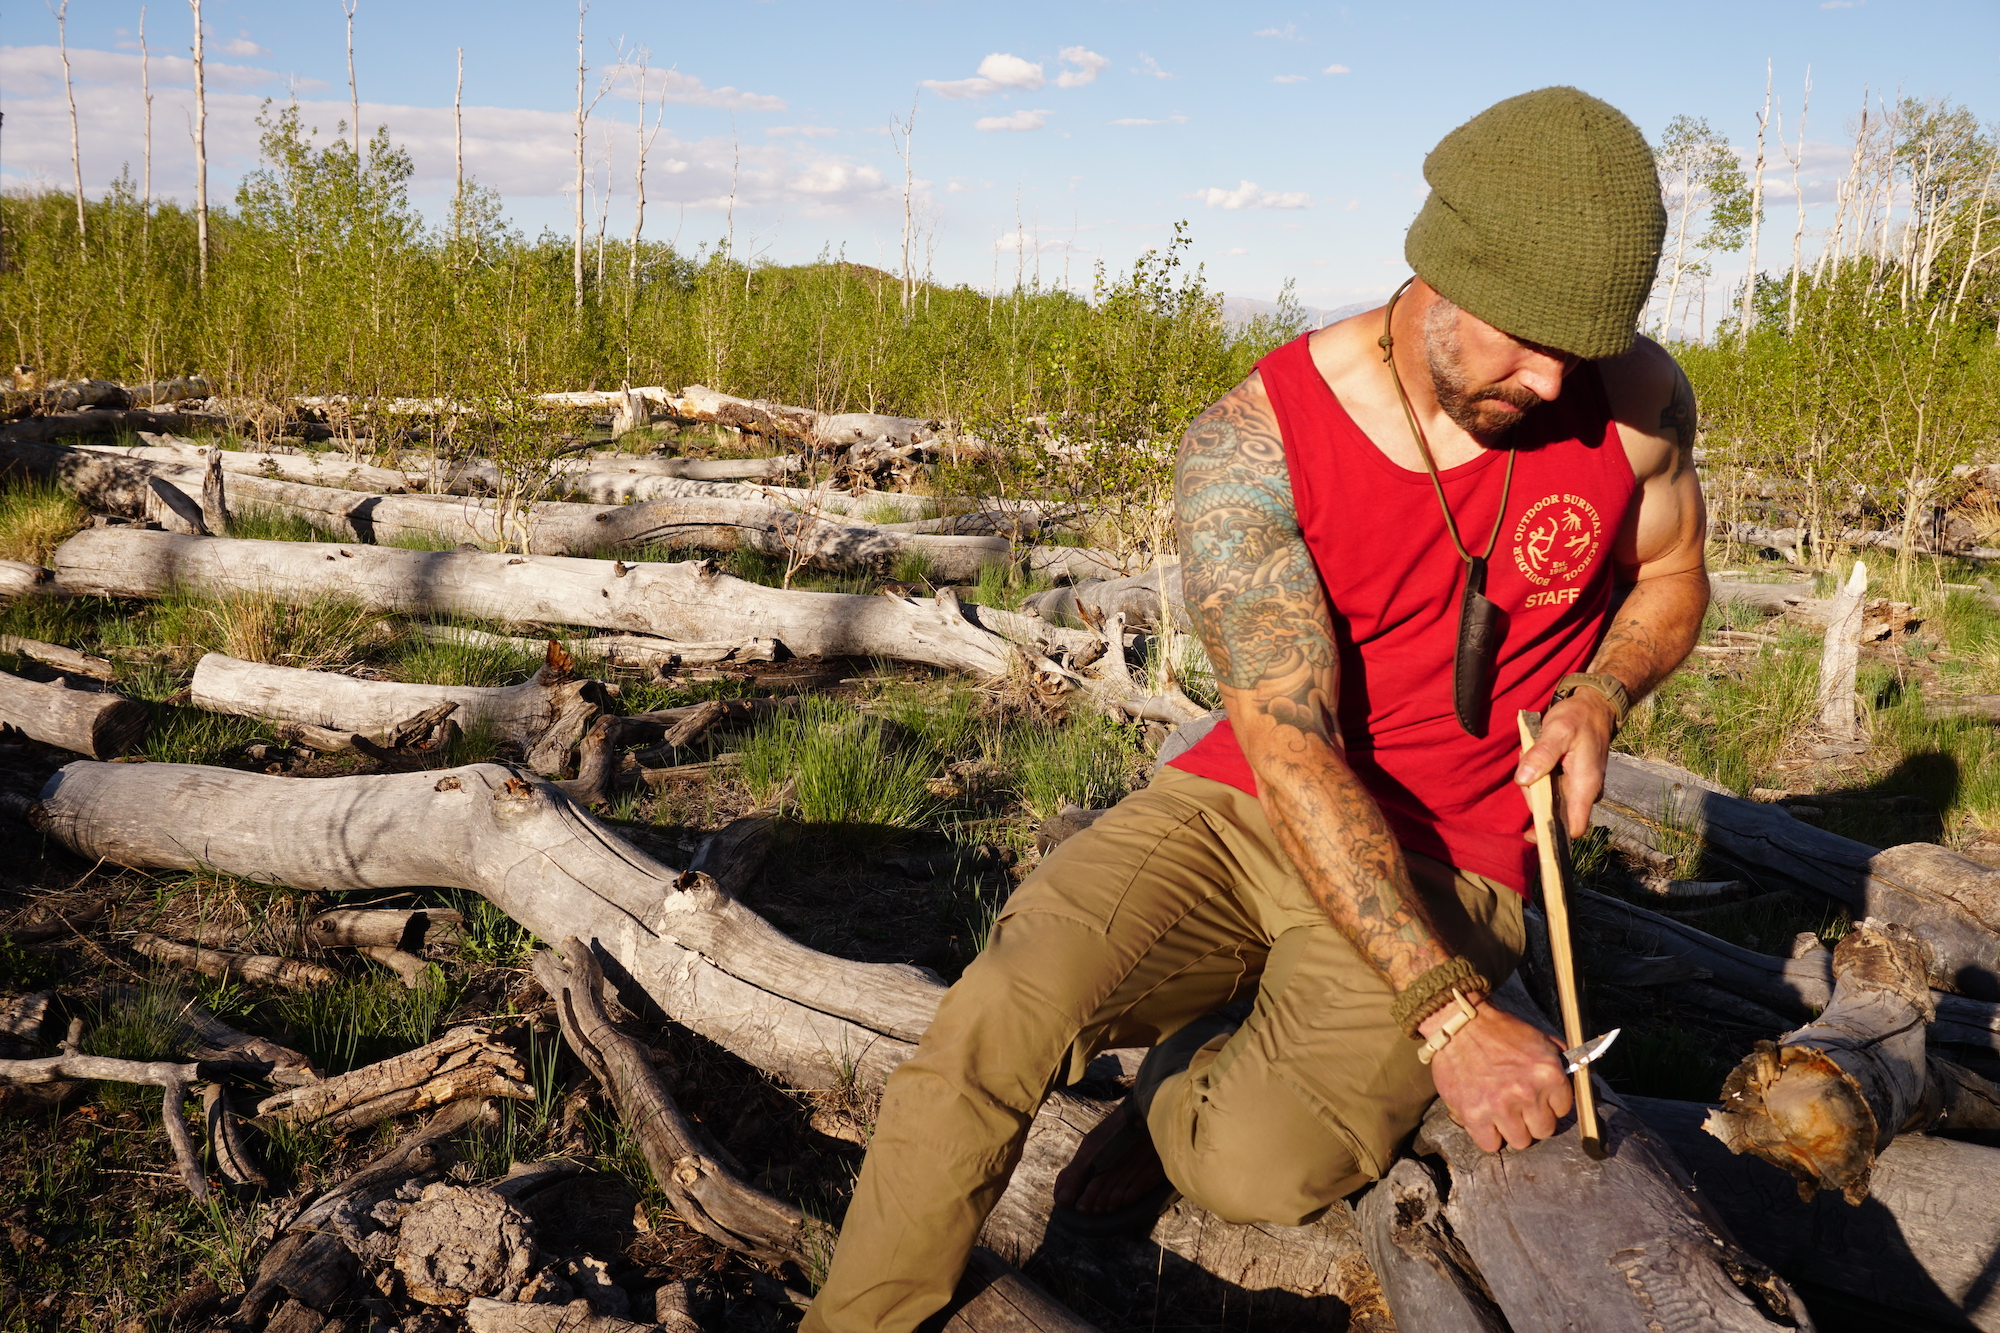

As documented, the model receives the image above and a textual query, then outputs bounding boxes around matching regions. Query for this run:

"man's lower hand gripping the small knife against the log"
[1420,1003,1572,1153]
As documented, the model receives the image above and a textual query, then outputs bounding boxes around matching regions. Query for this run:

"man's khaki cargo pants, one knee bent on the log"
[802,769,1522,1333]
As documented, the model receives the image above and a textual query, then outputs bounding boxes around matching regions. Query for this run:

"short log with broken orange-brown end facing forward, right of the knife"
[1704,925,2000,1203]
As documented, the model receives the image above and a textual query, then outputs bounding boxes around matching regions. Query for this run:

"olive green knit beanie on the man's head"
[1402,88,1666,356]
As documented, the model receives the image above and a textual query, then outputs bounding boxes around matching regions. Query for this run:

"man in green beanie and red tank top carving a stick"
[806,88,1708,1333]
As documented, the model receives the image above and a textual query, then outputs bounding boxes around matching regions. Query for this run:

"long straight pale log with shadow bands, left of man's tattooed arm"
[56,528,1010,677]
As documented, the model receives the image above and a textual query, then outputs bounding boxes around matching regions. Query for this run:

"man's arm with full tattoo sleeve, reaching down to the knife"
[1174,376,1570,1151]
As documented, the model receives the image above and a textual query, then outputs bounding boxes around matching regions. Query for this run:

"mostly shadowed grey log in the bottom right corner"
[1628,1097,2000,1333]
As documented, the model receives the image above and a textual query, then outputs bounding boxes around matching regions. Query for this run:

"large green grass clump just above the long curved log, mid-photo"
[742,697,938,843]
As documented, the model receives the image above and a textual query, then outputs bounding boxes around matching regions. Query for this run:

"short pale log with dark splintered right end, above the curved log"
[188,652,604,749]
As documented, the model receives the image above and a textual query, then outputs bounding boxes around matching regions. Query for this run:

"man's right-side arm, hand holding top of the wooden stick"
[1514,338,1708,837]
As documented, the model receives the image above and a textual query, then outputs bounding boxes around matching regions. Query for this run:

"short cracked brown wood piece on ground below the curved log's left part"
[256,1023,534,1133]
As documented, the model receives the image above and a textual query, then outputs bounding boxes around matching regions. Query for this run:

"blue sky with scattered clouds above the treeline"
[0,0,2000,308]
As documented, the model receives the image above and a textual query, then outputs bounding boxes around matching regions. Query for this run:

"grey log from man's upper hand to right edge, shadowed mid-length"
[1592,755,2000,1001]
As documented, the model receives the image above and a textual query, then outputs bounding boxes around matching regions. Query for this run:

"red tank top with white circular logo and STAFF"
[1172,334,1638,895]
